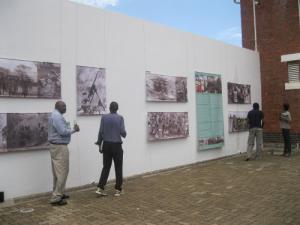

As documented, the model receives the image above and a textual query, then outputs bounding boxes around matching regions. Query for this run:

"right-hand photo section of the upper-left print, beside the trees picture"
[37,62,61,99]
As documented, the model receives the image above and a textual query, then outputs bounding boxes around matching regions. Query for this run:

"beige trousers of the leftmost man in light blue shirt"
[50,144,69,203]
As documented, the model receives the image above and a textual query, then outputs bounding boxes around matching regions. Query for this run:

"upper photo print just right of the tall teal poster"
[227,82,251,104]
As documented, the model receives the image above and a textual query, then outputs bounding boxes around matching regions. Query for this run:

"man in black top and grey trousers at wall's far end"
[246,102,264,161]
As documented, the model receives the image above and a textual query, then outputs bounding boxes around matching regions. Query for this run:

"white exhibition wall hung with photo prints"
[0,0,261,199]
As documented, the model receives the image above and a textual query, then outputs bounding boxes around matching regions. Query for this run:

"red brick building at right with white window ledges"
[239,0,300,142]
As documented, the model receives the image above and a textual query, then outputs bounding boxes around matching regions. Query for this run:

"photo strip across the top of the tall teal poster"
[195,73,222,94]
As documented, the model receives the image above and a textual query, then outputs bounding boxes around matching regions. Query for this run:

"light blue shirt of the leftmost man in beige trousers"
[48,110,75,144]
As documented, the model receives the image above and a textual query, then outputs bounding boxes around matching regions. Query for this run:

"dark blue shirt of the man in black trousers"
[97,113,126,146]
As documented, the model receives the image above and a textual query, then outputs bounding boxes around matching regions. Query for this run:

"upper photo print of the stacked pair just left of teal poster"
[146,71,187,102]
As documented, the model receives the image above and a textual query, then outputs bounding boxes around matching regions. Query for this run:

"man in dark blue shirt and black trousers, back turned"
[96,102,126,196]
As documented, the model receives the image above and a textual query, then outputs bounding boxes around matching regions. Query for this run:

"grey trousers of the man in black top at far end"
[247,128,263,159]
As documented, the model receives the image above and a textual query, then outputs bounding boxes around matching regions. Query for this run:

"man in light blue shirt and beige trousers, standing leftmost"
[48,101,79,205]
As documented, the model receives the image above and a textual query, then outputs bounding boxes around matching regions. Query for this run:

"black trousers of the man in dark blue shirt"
[98,142,123,191]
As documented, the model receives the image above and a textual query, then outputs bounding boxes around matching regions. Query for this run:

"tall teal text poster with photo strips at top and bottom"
[195,72,224,150]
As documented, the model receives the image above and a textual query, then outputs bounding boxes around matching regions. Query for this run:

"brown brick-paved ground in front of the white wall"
[0,153,300,225]
